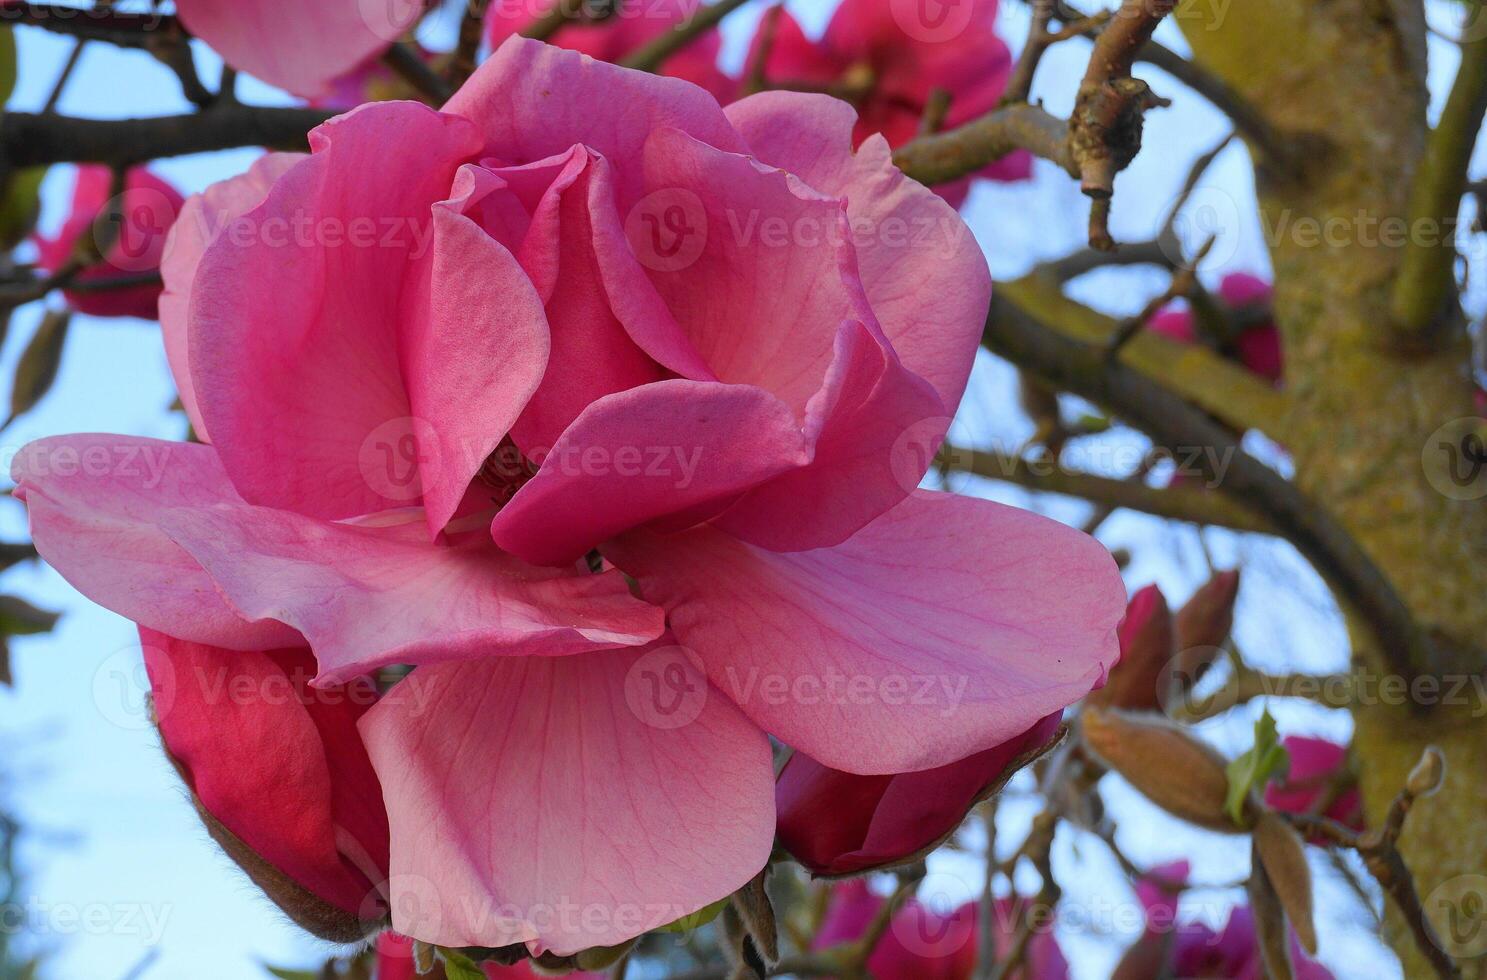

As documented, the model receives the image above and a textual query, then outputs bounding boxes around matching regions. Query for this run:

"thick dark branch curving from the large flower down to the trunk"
[983,290,1441,678]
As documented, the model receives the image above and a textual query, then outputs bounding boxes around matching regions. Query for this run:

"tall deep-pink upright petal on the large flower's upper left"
[189,103,489,519]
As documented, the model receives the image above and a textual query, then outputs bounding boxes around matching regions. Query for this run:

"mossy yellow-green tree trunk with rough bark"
[1178,0,1487,977]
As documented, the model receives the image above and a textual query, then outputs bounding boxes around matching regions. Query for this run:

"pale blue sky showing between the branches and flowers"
[0,1,1481,980]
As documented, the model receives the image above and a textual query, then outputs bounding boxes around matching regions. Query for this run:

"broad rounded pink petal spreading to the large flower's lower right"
[605,491,1126,775]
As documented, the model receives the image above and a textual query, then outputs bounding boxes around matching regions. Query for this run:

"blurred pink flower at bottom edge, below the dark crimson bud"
[812,879,1069,980]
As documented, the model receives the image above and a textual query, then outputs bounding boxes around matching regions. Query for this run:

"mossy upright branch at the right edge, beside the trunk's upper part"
[1389,29,1487,351]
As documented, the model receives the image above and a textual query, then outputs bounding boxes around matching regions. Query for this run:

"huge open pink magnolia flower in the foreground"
[13,39,1124,956]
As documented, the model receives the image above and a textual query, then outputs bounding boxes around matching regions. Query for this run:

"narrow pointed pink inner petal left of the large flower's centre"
[403,185,552,532]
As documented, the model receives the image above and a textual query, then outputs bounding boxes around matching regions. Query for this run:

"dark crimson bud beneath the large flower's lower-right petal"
[775,712,1062,876]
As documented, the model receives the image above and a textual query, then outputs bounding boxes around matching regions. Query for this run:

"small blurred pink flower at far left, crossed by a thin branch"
[36,164,184,320]
